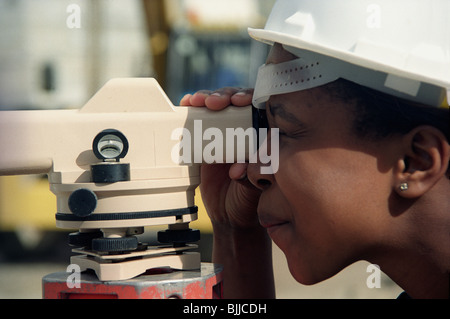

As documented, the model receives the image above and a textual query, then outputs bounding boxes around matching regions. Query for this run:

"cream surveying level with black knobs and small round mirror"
[0,78,254,300]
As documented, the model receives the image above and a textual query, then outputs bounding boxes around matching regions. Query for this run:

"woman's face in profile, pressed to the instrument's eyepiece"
[248,47,400,284]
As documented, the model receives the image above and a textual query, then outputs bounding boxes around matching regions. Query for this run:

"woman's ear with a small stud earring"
[394,126,450,198]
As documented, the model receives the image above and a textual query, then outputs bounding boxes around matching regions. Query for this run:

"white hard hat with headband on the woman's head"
[249,0,450,107]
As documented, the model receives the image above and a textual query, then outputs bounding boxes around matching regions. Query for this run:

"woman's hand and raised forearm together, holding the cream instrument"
[180,88,275,298]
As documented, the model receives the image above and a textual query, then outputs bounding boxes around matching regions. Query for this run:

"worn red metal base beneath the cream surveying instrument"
[42,263,222,299]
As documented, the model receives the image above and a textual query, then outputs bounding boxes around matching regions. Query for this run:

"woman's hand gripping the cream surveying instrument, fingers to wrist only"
[180,87,260,228]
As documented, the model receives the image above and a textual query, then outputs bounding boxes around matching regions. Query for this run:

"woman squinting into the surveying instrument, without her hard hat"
[180,1,450,298]
